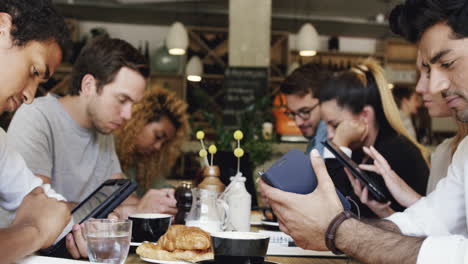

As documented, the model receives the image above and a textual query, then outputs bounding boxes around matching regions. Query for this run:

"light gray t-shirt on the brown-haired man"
[7,94,121,202]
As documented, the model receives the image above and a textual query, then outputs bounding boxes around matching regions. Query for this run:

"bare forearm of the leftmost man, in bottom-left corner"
[0,226,42,263]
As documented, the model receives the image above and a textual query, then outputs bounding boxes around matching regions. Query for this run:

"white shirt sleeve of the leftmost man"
[0,128,42,211]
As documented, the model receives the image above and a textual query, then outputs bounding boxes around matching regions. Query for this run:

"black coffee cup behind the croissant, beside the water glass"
[128,214,172,242]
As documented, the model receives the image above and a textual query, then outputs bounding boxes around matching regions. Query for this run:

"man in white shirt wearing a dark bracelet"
[260,0,468,264]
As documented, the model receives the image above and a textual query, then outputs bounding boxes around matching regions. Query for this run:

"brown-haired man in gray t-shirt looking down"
[8,38,176,258]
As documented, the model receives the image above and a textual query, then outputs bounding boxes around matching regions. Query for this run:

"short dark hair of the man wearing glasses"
[280,63,328,98]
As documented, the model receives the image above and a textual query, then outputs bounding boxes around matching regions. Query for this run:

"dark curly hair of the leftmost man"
[0,0,71,58]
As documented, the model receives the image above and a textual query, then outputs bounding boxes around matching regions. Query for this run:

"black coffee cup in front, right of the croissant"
[211,232,270,264]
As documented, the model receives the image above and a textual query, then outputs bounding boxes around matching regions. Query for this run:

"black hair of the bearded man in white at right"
[389,0,468,43]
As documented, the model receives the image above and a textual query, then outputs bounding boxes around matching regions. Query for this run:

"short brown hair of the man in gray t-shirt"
[68,37,150,95]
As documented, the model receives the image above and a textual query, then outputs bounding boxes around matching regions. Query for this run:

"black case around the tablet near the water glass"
[39,179,137,258]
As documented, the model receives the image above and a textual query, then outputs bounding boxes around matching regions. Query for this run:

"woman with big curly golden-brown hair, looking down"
[116,88,189,196]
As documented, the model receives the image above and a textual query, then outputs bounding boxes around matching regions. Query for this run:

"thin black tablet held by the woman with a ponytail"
[322,140,388,203]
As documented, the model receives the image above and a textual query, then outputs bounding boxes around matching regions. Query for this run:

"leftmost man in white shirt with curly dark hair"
[0,0,70,263]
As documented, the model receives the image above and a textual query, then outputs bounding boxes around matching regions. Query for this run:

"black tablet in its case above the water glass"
[39,179,137,258]
